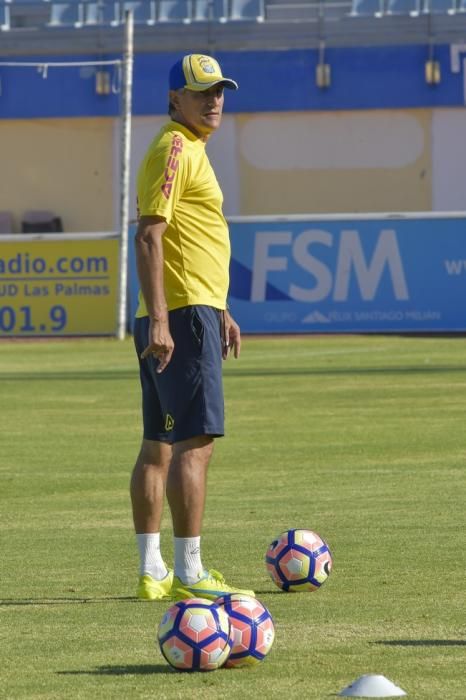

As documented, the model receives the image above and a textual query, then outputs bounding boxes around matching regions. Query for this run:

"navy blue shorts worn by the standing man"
[134,306,224,444]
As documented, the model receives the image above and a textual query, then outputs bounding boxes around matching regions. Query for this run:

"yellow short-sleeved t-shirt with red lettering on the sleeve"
[136,121,230,317]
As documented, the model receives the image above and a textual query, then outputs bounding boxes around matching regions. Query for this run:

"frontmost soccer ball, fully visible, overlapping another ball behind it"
[157,598,233,671]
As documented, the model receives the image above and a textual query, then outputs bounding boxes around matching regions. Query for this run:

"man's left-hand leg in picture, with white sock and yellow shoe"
[130,440,172,600]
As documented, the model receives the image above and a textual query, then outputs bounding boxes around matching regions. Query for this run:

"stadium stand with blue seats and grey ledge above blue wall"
[0,0,466,52]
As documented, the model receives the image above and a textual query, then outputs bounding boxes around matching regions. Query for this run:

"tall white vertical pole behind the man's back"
[117,10,134,340]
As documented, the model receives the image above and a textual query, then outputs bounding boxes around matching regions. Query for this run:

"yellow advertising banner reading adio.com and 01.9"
[0,234,119,338]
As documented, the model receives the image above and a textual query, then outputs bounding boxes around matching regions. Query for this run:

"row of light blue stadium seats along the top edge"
[0,0,466,31]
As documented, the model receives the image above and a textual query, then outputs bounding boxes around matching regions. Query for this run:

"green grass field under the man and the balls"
[0,336,466,700]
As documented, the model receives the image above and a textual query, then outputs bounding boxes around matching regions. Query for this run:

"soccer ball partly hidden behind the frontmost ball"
[215,593,275,668]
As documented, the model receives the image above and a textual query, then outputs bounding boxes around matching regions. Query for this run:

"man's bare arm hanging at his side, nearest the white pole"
[135,216,174,372]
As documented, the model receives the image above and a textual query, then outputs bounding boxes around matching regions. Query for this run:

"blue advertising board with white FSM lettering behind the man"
[130,213,466,333]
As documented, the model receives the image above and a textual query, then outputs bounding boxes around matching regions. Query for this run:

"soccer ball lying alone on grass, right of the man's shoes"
[265,529,332,592]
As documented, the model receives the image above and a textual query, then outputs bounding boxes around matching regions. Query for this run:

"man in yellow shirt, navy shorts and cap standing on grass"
[131,54,254,600]
